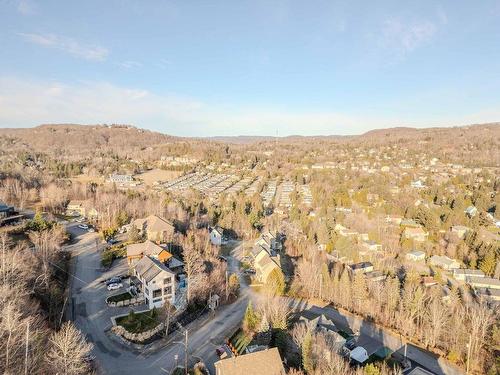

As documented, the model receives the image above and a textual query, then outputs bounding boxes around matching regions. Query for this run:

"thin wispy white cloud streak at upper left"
[18,33,109,61]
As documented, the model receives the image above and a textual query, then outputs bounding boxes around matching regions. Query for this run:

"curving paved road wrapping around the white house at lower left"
[67,224,248,375]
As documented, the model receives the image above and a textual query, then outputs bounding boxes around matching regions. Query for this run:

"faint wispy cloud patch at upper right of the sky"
[381,18,436,55]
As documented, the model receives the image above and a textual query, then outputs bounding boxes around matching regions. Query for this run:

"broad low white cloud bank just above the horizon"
[0,77,500,136]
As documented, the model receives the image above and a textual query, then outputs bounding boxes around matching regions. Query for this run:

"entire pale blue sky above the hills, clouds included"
[0,0,500,136]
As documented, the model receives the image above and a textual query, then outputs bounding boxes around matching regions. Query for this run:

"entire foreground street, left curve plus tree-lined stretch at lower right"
[67,224,462,375]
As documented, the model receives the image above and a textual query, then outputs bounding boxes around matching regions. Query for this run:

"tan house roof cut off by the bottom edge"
[214,348,286,375]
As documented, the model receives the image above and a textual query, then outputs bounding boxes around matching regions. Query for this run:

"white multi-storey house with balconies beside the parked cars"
[132,256,175,309]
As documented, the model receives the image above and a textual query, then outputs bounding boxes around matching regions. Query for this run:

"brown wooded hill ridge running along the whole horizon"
[0,123,500,155]
